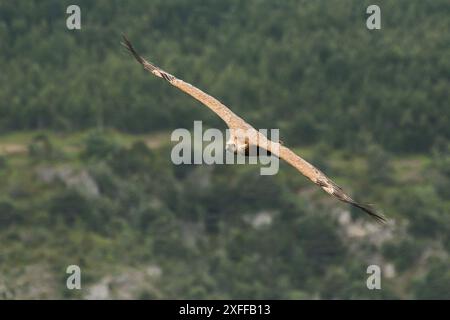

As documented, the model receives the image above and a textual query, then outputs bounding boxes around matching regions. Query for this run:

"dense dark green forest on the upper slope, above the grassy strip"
[0,0,450,153]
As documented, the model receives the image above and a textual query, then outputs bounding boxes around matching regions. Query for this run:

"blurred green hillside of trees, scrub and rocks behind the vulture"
[0,0,450,299]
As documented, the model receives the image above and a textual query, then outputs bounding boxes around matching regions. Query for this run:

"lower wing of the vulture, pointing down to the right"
[253,138,386,223]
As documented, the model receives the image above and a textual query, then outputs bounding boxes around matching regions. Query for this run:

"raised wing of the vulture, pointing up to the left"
[122,36,249,128]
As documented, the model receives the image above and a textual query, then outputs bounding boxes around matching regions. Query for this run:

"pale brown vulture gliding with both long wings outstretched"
[122,36,386,222]
